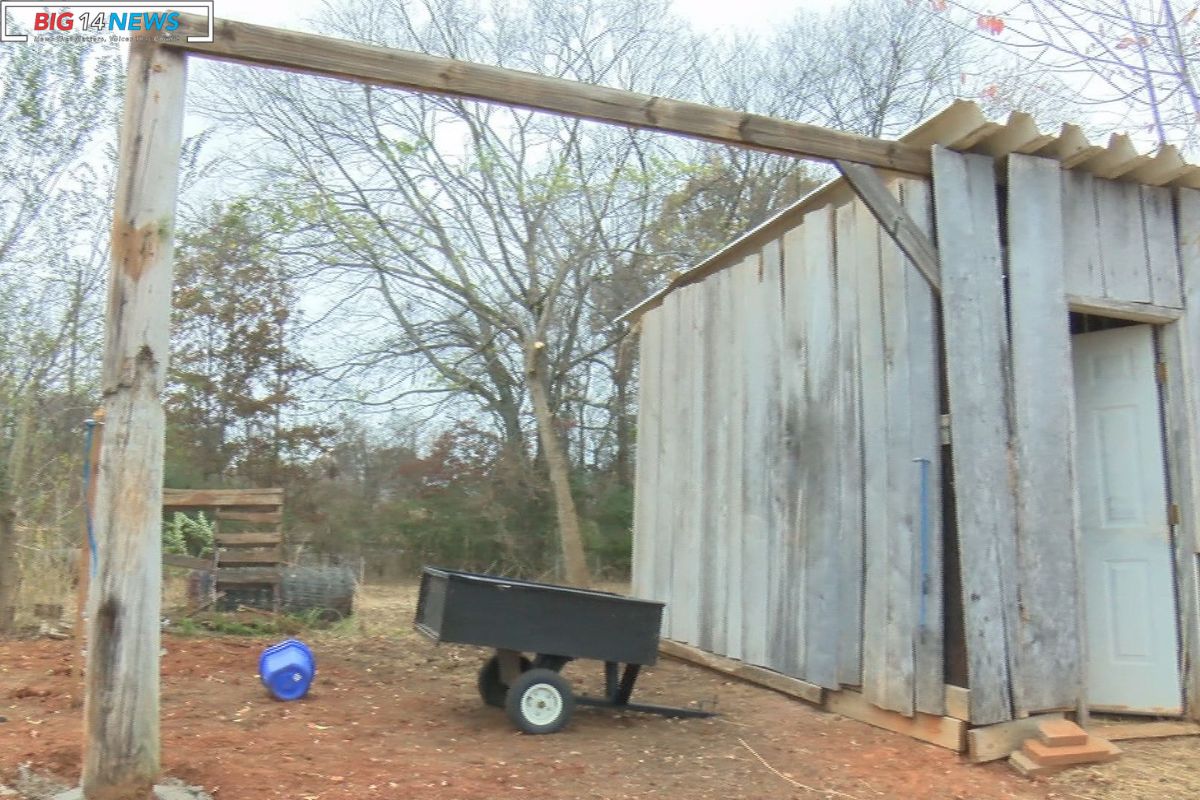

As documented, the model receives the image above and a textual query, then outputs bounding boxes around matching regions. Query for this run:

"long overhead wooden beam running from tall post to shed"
[162,14,930,175]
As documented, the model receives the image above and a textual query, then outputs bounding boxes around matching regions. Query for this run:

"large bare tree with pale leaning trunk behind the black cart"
[188,0,734,583]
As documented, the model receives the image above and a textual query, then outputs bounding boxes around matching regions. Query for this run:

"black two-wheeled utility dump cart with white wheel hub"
[416,566,712,733]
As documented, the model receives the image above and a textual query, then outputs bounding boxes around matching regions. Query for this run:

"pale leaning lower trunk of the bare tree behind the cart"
[526,342,592,587]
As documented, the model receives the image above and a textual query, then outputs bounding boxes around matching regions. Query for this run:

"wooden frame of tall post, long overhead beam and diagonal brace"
[83,14,937,798]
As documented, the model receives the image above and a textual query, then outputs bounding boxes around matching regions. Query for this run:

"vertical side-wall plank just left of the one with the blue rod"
[878,191,919,716]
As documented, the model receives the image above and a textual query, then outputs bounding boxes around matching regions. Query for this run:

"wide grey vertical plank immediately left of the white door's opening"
[1008,154,1084,716]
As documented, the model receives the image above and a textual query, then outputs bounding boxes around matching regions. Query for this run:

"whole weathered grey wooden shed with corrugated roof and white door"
[628,102,1200,754]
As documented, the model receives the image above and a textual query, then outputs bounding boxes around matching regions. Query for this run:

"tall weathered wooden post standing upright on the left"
[83,41,186,800]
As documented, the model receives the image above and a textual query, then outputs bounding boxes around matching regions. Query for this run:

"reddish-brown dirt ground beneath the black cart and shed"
[0,588,1200,800]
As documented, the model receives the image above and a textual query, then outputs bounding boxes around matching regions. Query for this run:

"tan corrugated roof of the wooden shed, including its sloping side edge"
[620,100,1200,320]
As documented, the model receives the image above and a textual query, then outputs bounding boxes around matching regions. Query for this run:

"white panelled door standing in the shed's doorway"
[1072,325,1183,715]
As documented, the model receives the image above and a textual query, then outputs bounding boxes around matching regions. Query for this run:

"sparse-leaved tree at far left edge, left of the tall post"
[0,47,119,628]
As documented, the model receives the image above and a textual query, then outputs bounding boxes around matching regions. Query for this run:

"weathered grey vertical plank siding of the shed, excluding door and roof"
[635,154,1200,724]
